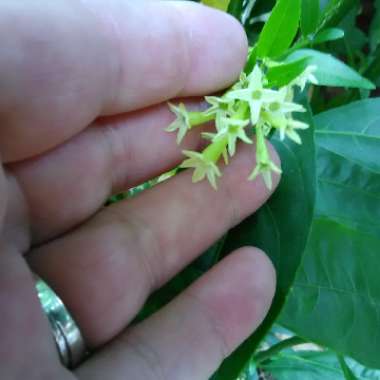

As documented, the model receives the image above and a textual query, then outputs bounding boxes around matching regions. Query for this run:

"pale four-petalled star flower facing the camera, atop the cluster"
[225,65,276,125]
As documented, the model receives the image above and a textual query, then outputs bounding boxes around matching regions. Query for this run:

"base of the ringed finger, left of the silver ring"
[0,242,73,380]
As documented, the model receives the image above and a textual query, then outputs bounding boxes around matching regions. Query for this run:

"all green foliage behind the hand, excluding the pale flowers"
[131,0,380,380]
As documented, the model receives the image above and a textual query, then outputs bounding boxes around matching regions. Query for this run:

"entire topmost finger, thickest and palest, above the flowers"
[0,0,247,162]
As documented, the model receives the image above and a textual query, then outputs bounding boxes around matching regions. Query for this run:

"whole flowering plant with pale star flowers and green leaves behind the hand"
[128,0,380,380]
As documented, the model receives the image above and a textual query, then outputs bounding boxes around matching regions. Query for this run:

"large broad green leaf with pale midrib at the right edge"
[281,98,380,368]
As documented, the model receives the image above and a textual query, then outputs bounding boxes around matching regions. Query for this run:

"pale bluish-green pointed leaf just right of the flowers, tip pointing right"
[287,49,375,90]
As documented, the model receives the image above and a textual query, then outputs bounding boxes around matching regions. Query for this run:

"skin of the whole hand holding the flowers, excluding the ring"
[0,0,279,380]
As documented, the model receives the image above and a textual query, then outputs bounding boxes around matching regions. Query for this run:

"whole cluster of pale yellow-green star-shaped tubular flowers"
[166,64,317,193]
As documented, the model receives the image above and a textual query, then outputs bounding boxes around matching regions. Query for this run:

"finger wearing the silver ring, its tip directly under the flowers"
[30,147,279,346]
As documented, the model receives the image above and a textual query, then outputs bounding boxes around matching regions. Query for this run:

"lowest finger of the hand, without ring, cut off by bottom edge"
[77,248,275,380]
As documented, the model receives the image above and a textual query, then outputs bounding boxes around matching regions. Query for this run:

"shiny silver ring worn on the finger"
[34,275,86,368]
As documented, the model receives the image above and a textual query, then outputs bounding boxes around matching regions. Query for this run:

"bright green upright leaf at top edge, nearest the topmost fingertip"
[257,0,301,58]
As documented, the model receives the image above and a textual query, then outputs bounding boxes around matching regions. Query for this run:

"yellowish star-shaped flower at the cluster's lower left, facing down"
[180,150,222,190]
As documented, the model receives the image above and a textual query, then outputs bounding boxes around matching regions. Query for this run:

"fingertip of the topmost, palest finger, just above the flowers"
[171,1,248,96]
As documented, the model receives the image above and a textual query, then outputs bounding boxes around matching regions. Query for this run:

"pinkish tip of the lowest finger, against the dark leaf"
[192,247,276,355]
